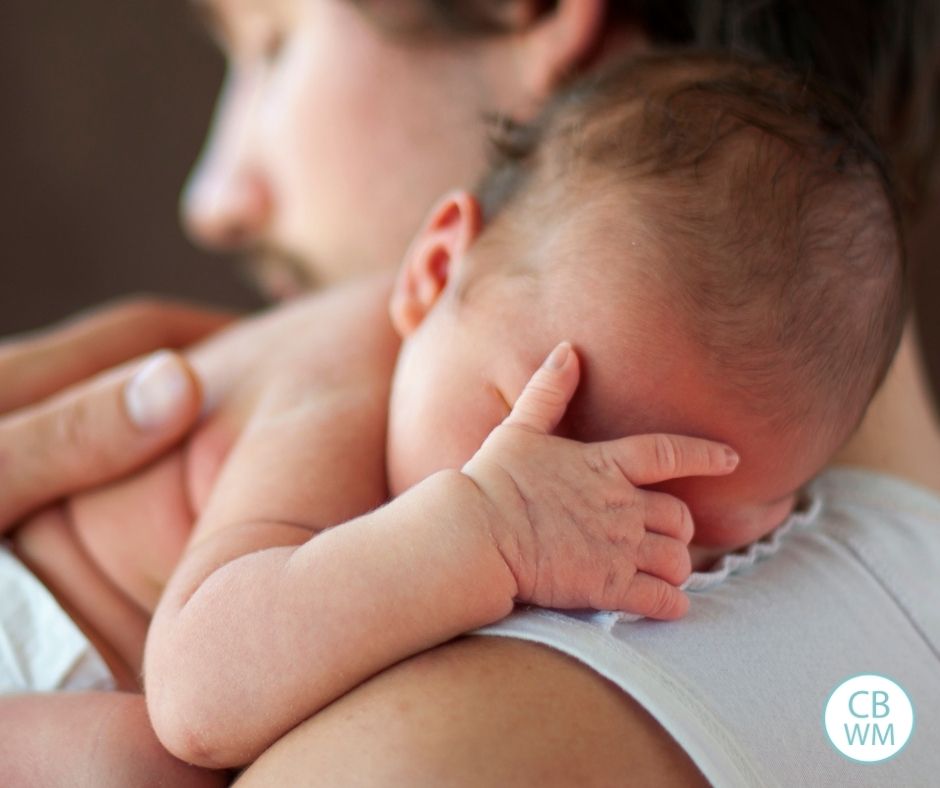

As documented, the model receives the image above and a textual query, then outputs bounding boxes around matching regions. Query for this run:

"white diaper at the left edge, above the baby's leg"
[0,542,115,694]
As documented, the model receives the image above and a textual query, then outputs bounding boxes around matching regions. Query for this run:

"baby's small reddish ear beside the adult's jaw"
[389,191,483,339]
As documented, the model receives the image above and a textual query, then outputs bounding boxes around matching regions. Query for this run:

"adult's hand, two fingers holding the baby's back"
[0,299,231,533]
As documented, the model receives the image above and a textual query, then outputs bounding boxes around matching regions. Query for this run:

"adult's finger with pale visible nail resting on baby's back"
[0,351,201,532]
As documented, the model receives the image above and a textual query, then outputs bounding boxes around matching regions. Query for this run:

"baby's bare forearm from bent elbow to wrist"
[146,472,516,766]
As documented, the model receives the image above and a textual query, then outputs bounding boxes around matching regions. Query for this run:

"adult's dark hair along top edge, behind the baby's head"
[353,0,940,214]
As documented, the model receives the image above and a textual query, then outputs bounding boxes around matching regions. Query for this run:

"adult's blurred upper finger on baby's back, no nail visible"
[0,298,233,413]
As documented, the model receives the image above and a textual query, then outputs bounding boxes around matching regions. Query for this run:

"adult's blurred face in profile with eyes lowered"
[183,0,544,297]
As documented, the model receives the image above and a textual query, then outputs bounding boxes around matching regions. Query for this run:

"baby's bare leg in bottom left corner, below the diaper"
[0,692,229,788]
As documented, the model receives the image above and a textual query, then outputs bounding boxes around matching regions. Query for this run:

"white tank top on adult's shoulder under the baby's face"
[472,468,940,788]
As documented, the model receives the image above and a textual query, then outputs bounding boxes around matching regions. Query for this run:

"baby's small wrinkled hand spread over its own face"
[462,343,738,619]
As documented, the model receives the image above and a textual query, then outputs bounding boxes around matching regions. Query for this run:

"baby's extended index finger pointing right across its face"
[603,433,739,487]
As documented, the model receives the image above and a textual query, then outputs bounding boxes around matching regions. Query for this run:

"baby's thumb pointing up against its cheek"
[503,342,580,435]
